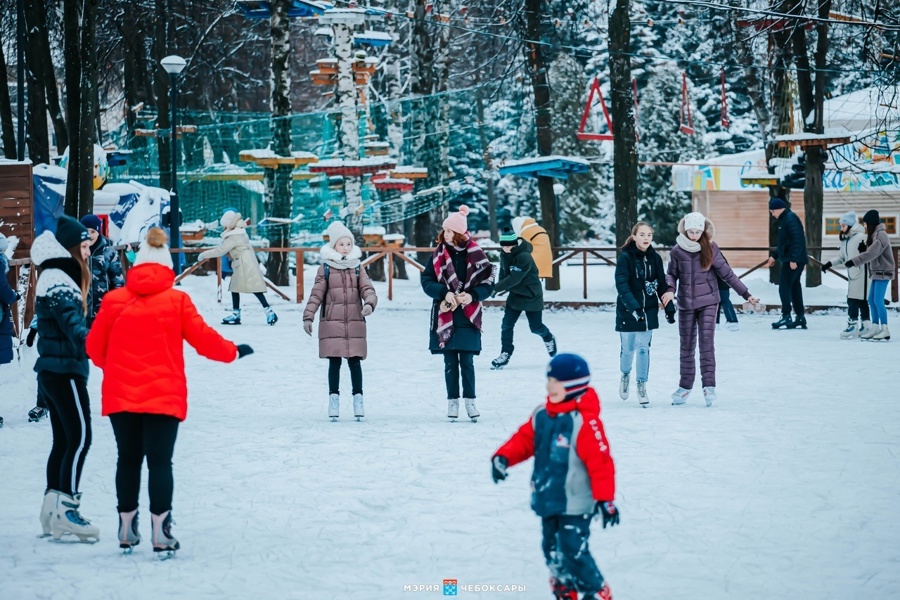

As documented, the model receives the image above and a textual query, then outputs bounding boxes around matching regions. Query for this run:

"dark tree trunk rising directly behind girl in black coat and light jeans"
[609,0,638,251]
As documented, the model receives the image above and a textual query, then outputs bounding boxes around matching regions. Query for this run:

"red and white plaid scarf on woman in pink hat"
[432,239,494,348]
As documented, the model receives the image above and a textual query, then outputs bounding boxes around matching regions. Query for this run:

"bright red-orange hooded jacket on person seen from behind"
[87,263,238,421]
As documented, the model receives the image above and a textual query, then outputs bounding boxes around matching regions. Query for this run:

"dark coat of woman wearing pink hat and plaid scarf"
[421,247,494,354]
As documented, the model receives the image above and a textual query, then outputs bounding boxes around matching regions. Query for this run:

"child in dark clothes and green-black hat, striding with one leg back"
[491,227,556,369]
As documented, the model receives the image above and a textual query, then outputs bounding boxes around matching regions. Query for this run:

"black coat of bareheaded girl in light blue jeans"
[616,240,666,331]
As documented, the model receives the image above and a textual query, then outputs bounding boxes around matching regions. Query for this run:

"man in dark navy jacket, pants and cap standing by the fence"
[766,198,809,329]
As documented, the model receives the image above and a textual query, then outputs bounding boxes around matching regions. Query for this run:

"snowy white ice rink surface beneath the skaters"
[0,269,900,600]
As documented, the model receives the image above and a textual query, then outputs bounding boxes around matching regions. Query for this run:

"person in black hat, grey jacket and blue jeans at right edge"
[844,210,895,341]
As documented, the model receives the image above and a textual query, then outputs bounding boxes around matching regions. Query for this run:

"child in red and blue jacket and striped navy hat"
[491,354,619,600]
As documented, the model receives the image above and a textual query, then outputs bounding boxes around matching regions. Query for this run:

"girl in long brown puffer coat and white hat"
[303,221,378,421]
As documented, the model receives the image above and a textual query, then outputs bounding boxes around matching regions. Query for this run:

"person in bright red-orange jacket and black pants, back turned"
[87,227,253,558]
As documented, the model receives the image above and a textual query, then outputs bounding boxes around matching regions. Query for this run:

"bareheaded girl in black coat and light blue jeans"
[615,221,675,407]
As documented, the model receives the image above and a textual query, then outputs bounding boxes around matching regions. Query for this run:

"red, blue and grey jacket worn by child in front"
[494,388,616,516]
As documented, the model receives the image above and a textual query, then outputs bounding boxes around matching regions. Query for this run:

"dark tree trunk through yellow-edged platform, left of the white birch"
[266,0,294,285]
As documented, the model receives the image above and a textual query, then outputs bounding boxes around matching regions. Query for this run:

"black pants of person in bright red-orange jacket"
[109,412,179,515]
